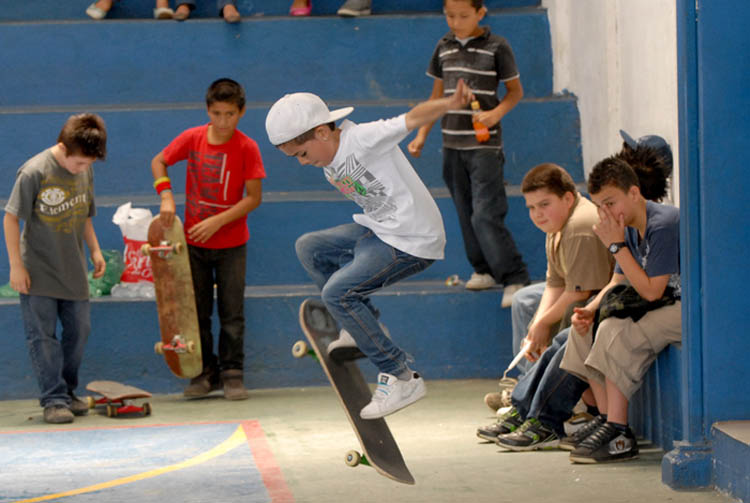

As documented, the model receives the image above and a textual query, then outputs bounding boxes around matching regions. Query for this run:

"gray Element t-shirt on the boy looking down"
[5,149,96,300]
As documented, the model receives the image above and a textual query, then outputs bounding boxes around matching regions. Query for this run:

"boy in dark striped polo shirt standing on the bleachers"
[408,0,529,307]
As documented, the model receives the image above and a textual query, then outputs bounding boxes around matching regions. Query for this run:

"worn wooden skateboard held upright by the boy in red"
[141,215,203,378]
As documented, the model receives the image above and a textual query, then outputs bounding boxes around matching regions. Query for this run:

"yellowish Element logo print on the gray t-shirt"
[34,177,90,234]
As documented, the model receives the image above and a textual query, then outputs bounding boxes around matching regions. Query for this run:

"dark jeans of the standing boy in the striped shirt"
[443,148,529,285]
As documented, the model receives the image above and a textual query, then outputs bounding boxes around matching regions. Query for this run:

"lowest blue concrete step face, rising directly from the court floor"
[0,281,511,400]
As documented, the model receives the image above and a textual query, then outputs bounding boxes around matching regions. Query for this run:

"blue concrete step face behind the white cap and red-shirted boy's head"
[0,96,583,198]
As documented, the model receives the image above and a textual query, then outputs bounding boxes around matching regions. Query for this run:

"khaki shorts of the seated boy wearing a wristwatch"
[560,301,682,399]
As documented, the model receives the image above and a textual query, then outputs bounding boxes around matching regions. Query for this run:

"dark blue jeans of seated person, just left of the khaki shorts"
[511,328,589,436]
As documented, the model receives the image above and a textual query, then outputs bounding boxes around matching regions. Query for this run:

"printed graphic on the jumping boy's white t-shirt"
[326,154,397,222]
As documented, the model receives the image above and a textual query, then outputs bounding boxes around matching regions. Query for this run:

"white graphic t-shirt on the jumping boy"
[325,115,445,260]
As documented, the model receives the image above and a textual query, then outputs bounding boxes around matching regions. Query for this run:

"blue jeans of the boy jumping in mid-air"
[295,223,434,375]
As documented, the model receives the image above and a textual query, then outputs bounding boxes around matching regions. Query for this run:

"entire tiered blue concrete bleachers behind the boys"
[0,0,583,399]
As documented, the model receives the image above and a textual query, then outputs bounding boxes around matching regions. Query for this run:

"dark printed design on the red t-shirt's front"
[185,150,232,222]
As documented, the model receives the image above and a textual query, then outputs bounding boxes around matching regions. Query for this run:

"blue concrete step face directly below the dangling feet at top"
[0,8,552,108]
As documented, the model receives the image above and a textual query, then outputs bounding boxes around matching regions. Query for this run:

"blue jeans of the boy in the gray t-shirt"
[20,294,91,407]
